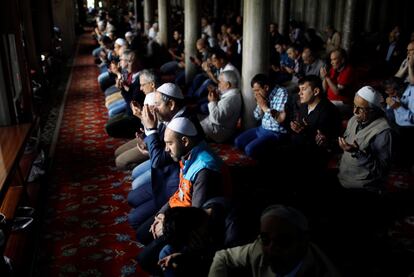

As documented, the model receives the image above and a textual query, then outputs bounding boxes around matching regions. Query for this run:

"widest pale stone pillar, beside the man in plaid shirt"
[241,0,270,129]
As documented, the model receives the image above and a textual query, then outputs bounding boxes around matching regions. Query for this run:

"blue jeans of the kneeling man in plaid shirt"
[234,126,283,158]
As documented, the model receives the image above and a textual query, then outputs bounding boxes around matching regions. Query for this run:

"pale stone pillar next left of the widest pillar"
[184,0,201,83]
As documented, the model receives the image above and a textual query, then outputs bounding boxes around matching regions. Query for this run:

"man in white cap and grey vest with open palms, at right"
[338,86,392,190]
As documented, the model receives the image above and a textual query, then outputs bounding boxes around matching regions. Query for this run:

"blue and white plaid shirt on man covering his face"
[254,86,288,134]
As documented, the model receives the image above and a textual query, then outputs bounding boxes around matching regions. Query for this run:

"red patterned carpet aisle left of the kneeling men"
[38,34,146,276]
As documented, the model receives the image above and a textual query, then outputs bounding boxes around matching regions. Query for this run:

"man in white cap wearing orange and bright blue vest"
[137,117,224,273]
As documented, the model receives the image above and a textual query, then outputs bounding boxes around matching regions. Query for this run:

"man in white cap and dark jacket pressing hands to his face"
[128,83,202,229]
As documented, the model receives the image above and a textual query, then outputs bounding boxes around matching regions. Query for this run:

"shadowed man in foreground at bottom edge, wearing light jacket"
[209,205,340,277]
